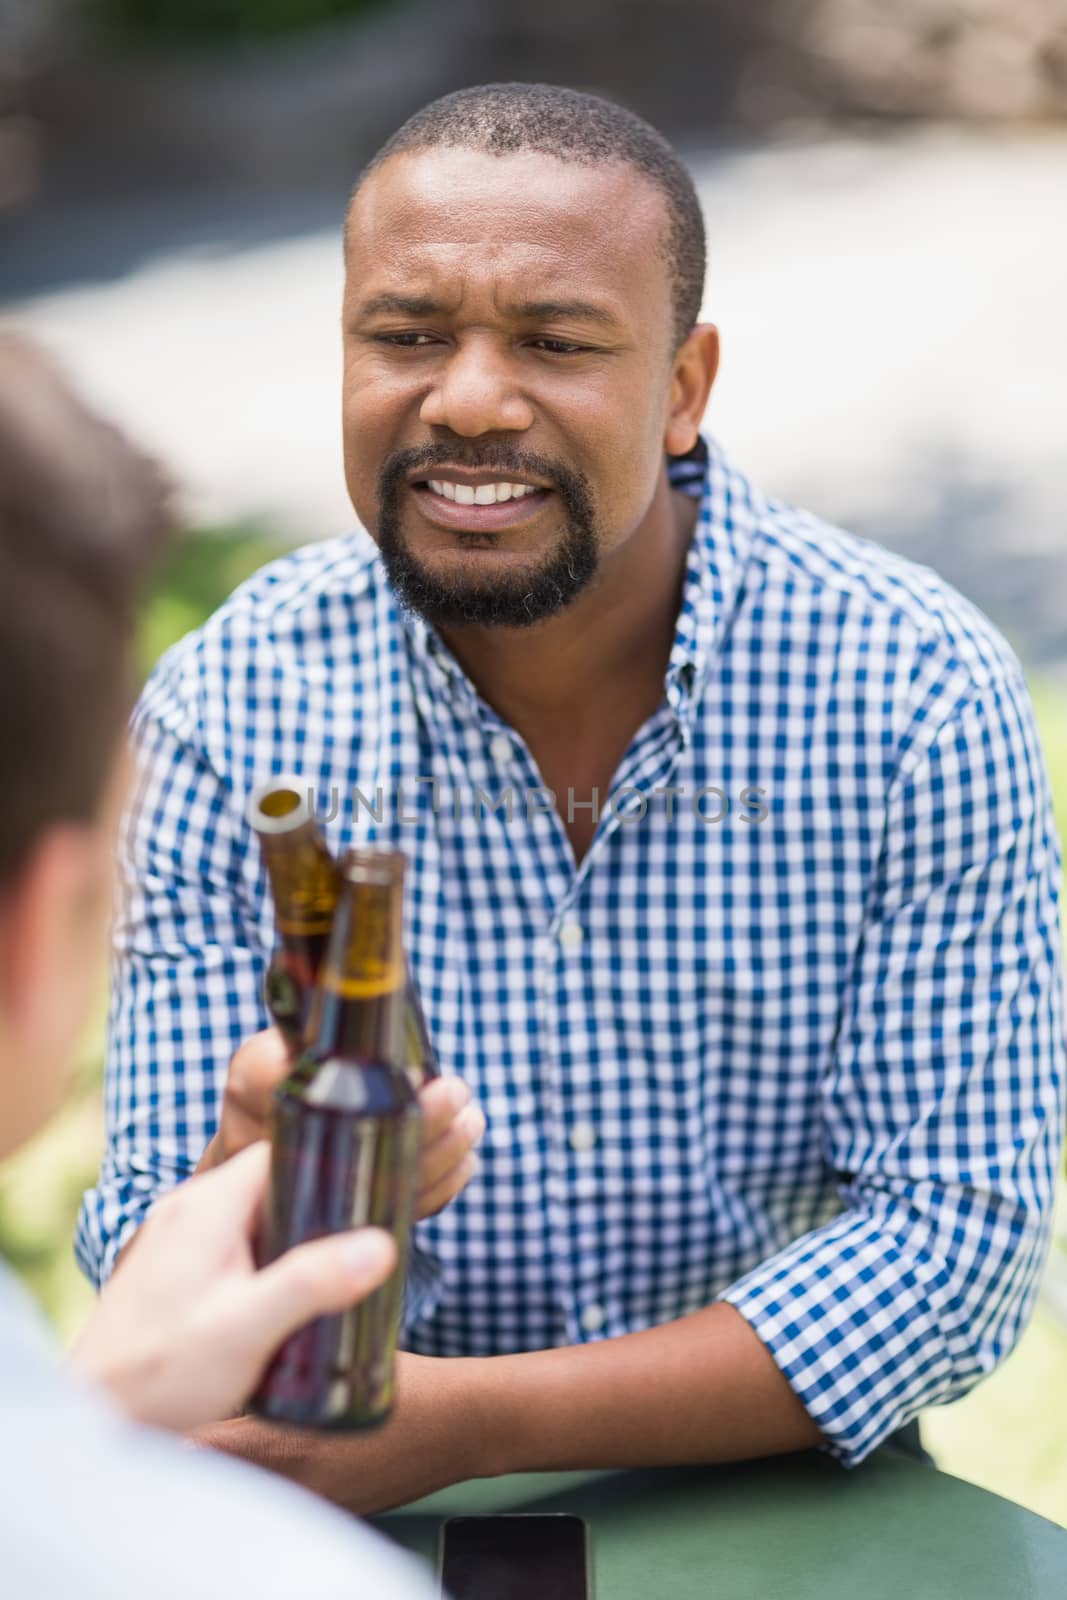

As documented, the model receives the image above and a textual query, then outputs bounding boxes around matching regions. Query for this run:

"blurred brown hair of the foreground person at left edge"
[0,330,173,890]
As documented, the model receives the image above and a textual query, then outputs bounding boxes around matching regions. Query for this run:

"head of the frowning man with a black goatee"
[344,83,718,627]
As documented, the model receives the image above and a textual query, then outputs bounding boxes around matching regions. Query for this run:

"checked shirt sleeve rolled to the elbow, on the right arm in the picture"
[721,670,1064,1466]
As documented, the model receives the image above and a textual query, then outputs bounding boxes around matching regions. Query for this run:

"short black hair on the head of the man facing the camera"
[352,83,705,349]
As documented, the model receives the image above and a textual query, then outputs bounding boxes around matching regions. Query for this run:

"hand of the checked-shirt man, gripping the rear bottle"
[197,1027,485,1218]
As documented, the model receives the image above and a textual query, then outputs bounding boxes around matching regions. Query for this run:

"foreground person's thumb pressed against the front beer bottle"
[243,1227,397,1350]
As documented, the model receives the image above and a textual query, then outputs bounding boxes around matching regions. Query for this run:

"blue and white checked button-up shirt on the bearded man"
[78,443,1064,1464]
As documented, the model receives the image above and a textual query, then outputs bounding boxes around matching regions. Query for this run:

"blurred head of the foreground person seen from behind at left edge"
[0,333,170,1157]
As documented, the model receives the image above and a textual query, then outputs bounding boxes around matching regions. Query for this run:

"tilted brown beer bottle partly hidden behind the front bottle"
[248,778,440,1088]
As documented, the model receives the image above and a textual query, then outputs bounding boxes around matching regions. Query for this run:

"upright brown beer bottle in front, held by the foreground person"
[251,850,421,1429]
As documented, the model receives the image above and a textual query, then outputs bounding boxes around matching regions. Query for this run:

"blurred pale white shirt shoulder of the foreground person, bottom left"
[0,1266,432,1600]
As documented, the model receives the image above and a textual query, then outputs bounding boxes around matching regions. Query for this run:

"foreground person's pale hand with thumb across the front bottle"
[70,1142,397,1429]
